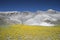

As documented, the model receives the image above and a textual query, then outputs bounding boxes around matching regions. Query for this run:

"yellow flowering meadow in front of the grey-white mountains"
[0,24,60,40]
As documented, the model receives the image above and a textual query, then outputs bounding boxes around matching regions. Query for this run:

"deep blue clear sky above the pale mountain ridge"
[0,0,60,11]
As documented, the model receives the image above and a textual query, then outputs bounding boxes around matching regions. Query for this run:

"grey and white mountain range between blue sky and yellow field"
[0,9,60,26]
